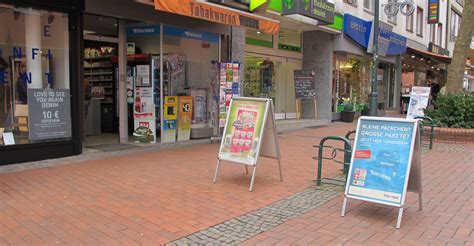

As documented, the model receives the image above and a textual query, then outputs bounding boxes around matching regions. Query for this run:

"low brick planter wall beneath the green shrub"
[432,126,474,143]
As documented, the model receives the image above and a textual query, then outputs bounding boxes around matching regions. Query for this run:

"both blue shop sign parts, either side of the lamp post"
[344,14,407,55]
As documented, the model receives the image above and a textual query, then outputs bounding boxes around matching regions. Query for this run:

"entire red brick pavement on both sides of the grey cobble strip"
[0,124,474,245]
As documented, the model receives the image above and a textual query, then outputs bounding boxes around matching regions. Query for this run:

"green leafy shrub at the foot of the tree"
[425,93,474,128]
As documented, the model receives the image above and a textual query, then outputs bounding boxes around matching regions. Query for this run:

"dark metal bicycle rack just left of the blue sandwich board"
[313,133,352,186]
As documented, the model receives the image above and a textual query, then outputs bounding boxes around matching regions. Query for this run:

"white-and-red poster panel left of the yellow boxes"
[133,87,156,143]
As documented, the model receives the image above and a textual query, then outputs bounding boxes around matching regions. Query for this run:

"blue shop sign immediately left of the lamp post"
[344,14,372,48]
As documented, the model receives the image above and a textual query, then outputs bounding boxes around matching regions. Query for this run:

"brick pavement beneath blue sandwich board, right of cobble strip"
[243,143,474,245]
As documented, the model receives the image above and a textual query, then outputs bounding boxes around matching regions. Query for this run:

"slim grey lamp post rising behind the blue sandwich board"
[369,0,380,116]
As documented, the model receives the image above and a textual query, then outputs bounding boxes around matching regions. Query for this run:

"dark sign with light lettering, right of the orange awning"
[282,0,335,24]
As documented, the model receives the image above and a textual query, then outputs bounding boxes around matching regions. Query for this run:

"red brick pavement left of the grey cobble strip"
[0,124,354,245]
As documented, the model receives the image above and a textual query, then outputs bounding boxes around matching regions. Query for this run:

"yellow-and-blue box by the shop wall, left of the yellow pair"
[161,96,178,143]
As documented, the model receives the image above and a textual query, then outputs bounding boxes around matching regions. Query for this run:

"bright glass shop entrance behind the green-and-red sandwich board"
[244,53,302,120]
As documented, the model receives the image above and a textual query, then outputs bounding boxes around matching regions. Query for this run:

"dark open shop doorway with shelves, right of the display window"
[83,14,119,147]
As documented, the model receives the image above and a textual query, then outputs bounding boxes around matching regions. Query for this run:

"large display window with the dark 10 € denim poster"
[0,4,72,145]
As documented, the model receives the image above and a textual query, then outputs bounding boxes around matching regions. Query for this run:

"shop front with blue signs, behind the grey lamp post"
[332,14,407,120]
